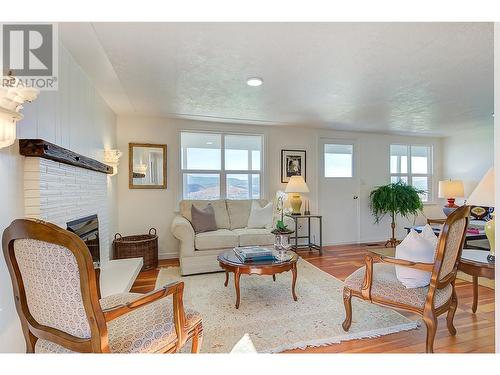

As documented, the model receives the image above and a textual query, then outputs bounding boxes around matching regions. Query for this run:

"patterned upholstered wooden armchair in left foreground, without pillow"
[2,220,202,353]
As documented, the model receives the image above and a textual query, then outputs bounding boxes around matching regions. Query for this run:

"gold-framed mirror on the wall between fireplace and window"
[128,143,167,189]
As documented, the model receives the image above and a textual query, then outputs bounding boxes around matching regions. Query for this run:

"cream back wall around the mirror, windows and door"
[117,116,442,258]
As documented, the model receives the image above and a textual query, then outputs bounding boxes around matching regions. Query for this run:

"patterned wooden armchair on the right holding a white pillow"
[342,206,470,353]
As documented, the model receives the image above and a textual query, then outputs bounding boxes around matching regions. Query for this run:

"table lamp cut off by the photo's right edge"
[467,168,495,262]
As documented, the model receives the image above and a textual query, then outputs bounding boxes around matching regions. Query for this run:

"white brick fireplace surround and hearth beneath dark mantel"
[24,157,143,297]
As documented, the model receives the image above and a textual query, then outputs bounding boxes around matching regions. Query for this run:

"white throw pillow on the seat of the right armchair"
[396,226,437,289]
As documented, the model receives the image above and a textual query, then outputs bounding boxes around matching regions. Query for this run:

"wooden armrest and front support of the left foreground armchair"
[102,281,187,348]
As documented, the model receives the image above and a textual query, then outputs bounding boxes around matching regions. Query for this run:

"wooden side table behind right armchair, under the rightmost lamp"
[458,249,495,313]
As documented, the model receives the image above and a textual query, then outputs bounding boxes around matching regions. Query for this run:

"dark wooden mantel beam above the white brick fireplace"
[19,139,113,174]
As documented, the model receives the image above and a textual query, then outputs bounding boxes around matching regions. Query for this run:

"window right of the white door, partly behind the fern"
[391,145,432,202]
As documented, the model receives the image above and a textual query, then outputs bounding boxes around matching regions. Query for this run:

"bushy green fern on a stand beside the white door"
[370,181,424,247]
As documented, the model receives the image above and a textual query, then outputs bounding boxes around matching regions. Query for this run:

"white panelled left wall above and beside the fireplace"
[0,45,116,352]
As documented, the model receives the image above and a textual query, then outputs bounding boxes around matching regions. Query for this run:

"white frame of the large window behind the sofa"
[179,129,265,200]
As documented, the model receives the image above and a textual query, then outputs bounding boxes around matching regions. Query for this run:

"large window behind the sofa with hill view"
[181,132,262,199]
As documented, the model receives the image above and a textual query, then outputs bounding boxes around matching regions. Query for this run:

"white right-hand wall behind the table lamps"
[443,125,495,203]
